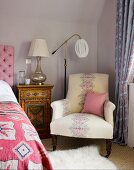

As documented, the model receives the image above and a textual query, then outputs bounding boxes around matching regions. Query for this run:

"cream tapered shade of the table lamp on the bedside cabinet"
[28,39,49,57]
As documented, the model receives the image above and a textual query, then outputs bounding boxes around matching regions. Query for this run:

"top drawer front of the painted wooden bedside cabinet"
[20,89,51,99]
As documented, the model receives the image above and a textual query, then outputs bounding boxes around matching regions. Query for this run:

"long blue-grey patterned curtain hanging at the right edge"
[114,0,134,145]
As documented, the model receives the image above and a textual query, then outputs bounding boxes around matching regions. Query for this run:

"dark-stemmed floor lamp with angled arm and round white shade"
[52,34,89,98]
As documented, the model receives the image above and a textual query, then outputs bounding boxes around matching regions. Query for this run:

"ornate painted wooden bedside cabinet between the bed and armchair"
[17,85,53,139]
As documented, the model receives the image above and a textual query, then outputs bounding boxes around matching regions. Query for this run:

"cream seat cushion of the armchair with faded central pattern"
[50,113,113,139]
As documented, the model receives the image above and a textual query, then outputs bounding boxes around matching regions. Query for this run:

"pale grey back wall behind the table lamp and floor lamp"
[0,15,97,100]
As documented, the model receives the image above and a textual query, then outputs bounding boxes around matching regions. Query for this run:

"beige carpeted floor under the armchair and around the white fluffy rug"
[42,136,134,170]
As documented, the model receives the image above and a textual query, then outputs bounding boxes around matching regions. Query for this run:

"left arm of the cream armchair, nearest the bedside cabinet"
[51,99,70,121]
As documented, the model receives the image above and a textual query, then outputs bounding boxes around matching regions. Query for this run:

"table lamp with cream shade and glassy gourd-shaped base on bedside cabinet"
[28,39,49,85]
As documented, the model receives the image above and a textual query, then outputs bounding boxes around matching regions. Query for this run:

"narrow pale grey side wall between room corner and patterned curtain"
[97,0,116,101]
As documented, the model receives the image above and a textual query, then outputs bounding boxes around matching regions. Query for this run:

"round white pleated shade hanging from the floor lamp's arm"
[75,39,89,58]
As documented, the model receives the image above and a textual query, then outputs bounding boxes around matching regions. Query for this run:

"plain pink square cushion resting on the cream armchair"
[82,92,108,117]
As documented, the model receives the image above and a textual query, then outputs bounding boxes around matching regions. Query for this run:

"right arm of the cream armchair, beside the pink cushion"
[104,101,115,126]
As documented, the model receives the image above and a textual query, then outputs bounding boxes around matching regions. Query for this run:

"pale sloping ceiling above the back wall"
[0,0,105,24]
